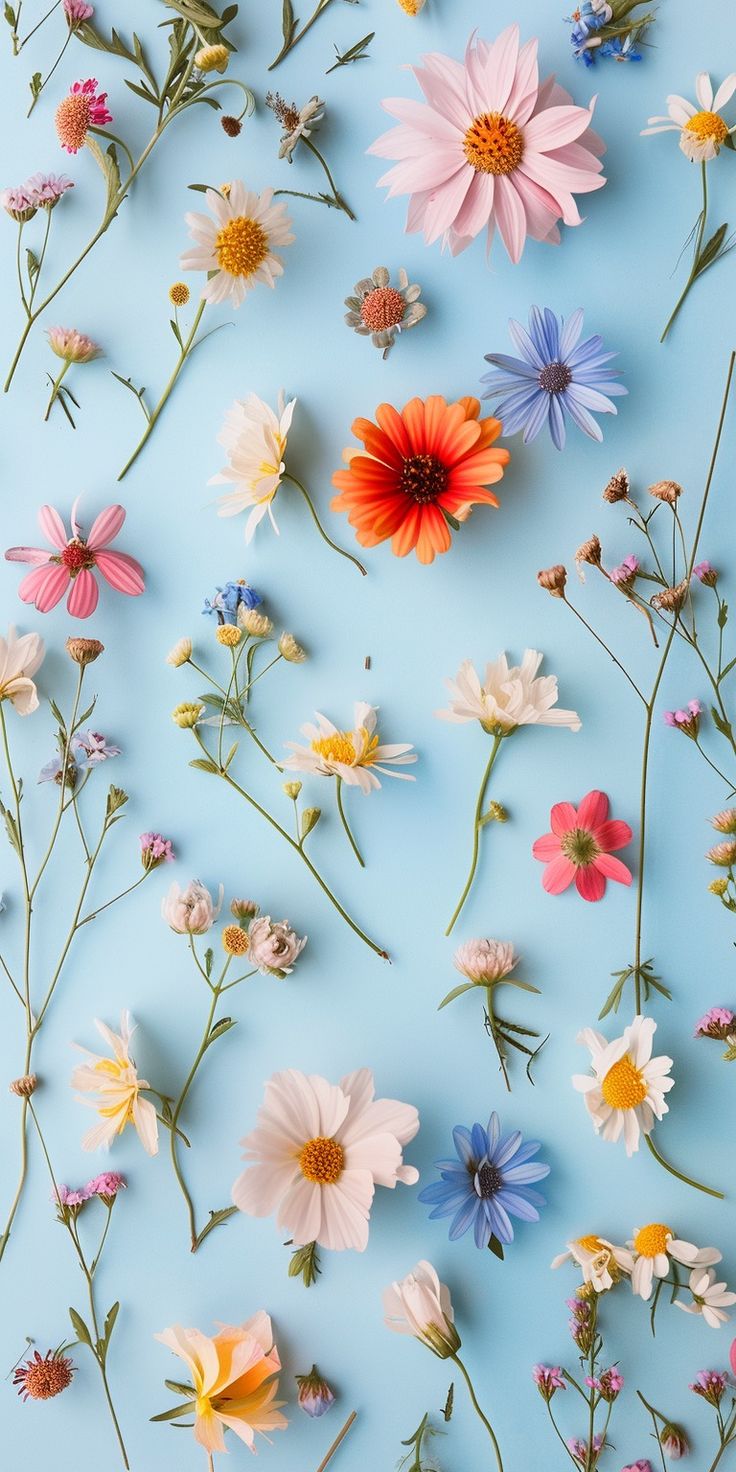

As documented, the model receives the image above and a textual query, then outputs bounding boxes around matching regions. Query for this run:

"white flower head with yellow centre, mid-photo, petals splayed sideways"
[283,701,417,793]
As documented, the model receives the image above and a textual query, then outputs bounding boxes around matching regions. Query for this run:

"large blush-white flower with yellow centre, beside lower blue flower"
[233,1069,420,1253]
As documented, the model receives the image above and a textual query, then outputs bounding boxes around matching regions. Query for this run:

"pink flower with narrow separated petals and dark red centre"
[6,500,144,618]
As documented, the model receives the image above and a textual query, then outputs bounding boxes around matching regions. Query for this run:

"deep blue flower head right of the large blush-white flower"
[420,1113,549,1247]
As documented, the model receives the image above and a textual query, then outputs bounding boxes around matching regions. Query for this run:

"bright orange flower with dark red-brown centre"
[333,394,509,562]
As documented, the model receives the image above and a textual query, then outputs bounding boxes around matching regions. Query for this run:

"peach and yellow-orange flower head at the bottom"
[153,1309,287,1456]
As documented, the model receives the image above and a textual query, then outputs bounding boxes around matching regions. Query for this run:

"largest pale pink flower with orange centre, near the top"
[368,25,605,262]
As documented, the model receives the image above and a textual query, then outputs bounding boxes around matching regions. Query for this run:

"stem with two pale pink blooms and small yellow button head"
[162,880,306,1253]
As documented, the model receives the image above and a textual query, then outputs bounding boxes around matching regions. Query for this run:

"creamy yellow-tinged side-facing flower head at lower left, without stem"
[72,1011,159,1156]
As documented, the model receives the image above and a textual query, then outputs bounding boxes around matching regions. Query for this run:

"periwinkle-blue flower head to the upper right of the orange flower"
[481,306,629,450]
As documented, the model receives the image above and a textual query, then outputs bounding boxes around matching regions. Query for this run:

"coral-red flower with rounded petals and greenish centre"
[531,790,633,899]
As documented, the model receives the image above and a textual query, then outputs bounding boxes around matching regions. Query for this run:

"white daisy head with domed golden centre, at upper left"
[181,180,294,306]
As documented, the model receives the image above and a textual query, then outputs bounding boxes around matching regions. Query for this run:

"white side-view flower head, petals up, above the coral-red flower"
[434,649,581,736]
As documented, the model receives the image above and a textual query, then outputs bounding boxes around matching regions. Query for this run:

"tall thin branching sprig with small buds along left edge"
[0,636,174,1259]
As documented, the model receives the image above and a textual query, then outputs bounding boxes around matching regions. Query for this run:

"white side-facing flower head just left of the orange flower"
[208,390,296,542]
